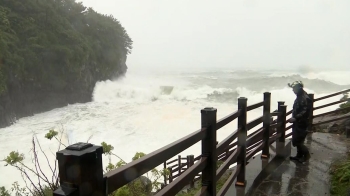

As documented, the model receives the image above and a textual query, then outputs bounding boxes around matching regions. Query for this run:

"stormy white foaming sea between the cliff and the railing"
[0,70,350,188]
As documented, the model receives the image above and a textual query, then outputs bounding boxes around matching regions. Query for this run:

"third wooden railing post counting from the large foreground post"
[236,97,247,186]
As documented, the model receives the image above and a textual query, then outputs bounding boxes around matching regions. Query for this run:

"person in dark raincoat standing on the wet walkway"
[288,81,311,163]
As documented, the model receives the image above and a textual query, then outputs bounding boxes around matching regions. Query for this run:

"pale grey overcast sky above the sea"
[78,0,350,70]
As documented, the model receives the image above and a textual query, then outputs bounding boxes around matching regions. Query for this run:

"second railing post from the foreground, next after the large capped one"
[201,108,218,196]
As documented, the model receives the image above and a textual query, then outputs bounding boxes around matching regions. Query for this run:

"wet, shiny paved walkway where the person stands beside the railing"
[249,133,350,196]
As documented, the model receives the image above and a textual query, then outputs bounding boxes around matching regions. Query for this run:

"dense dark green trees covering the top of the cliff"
[0,0,132,95]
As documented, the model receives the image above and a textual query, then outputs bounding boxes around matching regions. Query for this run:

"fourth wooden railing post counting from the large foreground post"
[261,92,271,158]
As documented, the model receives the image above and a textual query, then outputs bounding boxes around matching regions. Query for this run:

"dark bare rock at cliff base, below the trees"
[0,57,127,128]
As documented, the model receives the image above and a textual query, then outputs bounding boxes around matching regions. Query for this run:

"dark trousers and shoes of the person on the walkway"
[290,123,310,162]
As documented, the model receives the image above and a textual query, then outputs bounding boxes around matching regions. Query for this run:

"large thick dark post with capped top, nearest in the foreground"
[53,142,105,196]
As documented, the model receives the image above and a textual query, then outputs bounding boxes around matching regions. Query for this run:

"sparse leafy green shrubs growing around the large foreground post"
[0,130,169,196]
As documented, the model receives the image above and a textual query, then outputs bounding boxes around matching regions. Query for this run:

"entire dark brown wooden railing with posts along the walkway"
[54,89,350,196]
